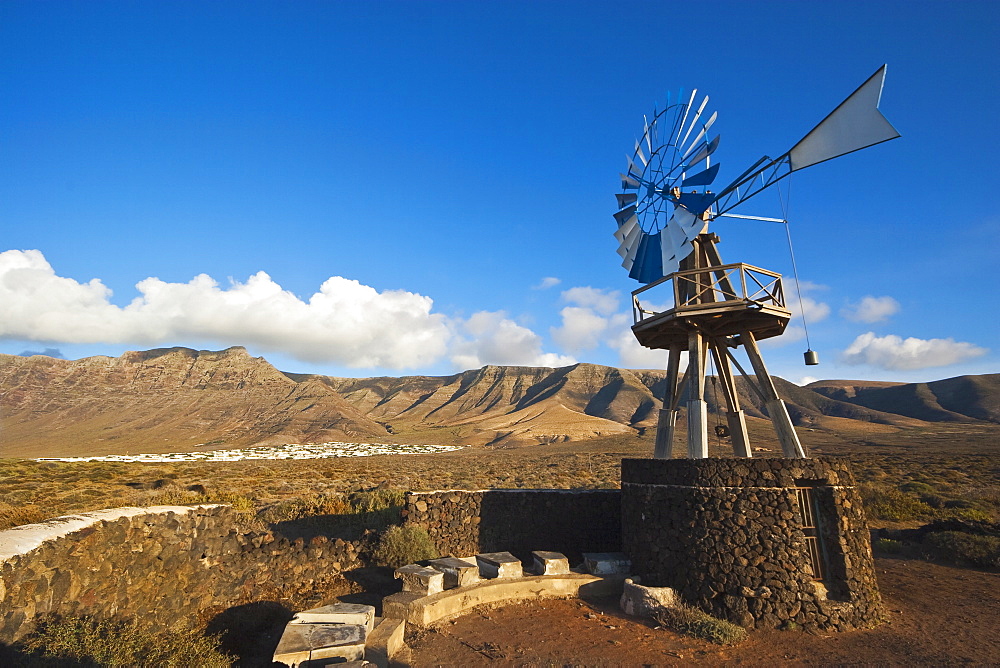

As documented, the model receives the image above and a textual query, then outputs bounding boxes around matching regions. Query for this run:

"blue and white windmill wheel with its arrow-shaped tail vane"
[614,65,899,283]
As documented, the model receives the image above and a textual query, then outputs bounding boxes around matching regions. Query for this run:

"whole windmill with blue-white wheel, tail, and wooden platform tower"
[614,65,899,458]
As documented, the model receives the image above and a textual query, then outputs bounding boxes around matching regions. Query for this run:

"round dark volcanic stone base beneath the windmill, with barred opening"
[622,458,881,630]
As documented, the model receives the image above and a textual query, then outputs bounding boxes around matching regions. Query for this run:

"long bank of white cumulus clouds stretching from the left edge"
[0,250,570,369]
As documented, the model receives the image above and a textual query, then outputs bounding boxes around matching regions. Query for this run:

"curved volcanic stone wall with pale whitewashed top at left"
[0,505,361,643]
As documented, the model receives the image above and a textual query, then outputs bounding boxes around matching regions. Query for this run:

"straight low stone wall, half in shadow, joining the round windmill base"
[403,489,622,564]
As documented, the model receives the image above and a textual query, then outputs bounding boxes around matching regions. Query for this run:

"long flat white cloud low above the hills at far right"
[841,332,988,371]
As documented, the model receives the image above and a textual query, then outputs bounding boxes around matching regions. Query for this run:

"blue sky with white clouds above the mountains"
[0,0,1000,381]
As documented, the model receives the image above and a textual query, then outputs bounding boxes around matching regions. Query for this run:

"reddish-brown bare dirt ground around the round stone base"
[399,558,1000,668]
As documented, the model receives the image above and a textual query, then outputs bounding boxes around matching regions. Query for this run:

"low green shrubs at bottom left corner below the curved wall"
[17,617,232,668]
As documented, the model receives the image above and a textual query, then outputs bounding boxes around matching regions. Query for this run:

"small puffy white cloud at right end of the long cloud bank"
[451,311,576,369]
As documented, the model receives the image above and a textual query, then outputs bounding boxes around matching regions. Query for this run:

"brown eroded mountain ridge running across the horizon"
[0,347,1000,456]
